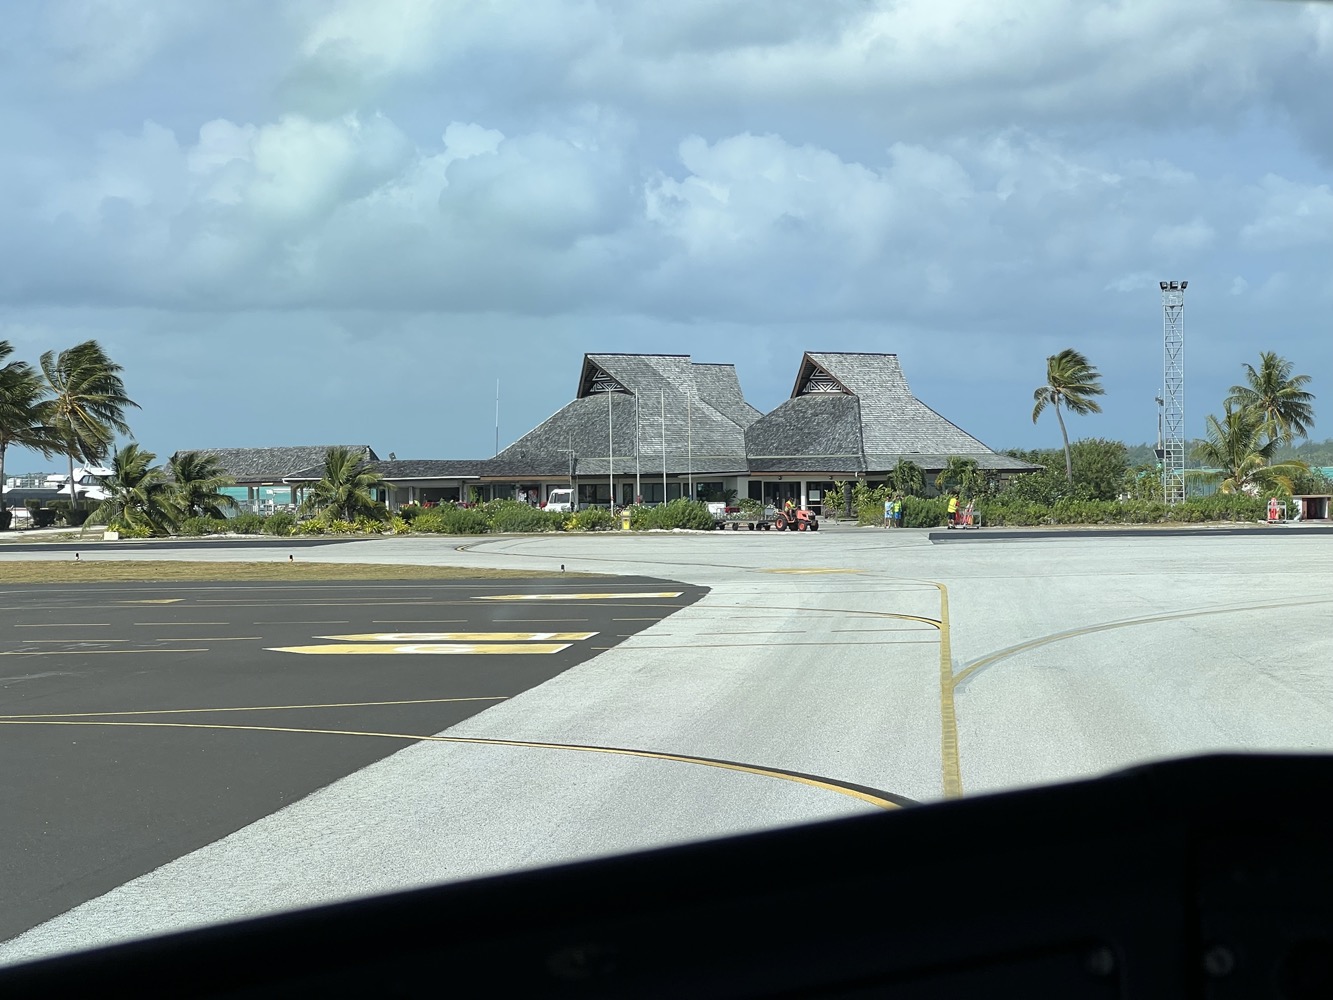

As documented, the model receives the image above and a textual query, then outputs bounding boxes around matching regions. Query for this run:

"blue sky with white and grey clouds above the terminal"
[0,0,1333,473]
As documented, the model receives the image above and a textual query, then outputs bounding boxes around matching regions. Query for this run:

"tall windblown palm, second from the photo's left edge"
[41,340,139,509]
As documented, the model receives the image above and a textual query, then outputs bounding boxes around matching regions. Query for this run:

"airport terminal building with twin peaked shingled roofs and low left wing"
[182,352,1037,509]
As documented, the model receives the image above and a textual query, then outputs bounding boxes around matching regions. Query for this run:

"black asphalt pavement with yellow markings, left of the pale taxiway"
[0,577,702,940]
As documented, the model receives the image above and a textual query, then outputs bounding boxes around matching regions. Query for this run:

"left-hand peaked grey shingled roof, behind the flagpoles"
[483,355,758,477]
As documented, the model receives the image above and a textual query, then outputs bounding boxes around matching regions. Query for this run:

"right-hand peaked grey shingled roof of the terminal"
[745,352,1036,472]
